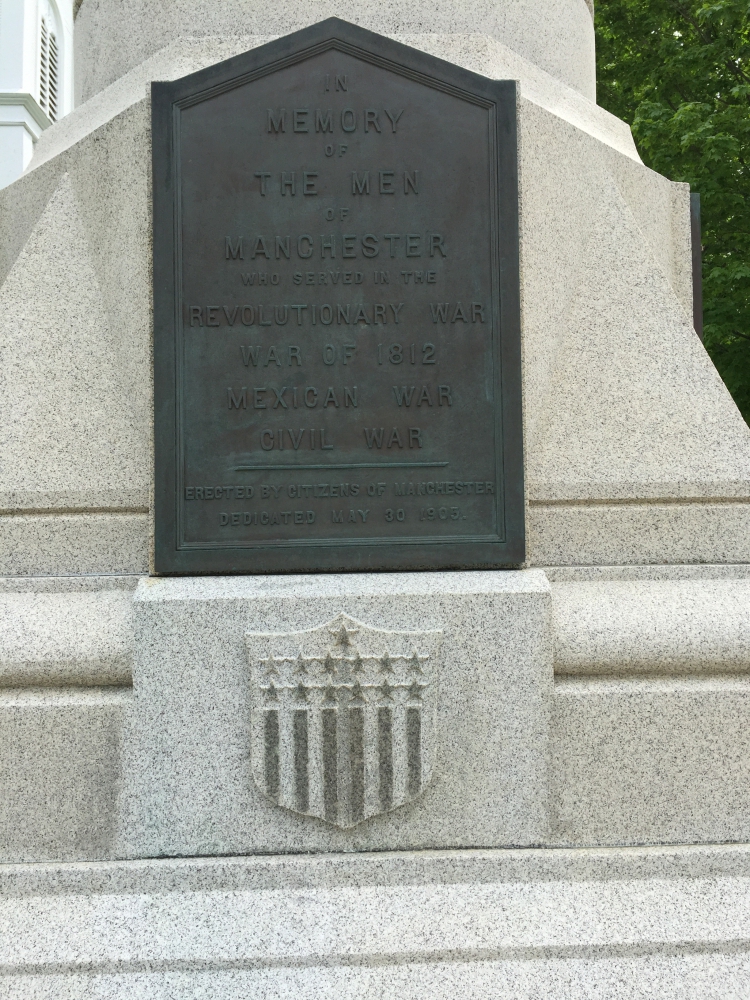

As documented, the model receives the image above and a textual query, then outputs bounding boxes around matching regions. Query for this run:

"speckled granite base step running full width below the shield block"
[0,847,750,1000]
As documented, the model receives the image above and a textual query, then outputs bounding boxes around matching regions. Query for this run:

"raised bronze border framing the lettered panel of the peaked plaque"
[151,17,525,575]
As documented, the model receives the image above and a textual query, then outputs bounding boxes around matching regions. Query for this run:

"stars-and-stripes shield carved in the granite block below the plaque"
[245,614,442,828]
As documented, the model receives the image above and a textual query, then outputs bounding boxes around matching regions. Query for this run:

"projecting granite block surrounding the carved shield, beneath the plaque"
[117,571,553,857]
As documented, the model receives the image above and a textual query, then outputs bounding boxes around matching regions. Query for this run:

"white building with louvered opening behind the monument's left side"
[0,0,74,187]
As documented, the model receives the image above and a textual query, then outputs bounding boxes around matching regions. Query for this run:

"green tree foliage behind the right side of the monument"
[596,0,750,423]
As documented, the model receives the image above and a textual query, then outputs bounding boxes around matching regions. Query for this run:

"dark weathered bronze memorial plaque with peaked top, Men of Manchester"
[153,19,524,573]
